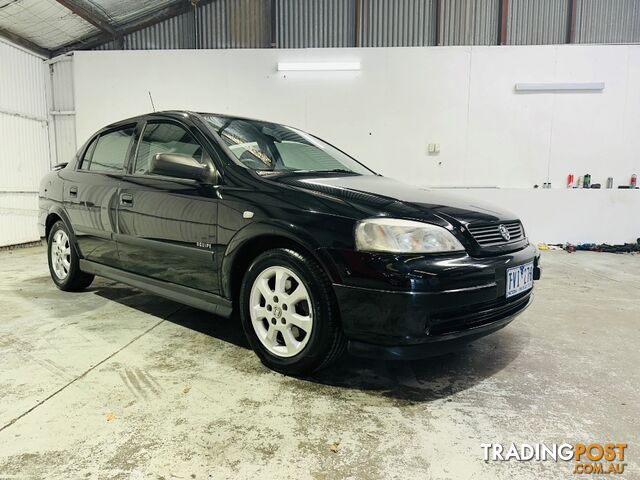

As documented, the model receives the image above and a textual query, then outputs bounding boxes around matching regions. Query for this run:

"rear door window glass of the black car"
[80,126,134,173]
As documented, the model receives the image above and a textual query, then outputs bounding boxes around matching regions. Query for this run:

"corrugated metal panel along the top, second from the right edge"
[507,0,571,45]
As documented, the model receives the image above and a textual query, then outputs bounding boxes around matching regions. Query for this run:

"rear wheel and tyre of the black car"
[47,221,94,291]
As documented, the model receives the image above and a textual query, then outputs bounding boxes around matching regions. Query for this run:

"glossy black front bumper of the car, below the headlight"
[324,247,541,359]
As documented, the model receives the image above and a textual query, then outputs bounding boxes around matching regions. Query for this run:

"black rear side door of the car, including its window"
[63,124,135,266]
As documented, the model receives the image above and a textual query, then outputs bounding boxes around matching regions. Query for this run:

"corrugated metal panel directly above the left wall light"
[276,0,356,48]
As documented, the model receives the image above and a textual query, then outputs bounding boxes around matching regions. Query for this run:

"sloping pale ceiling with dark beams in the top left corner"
[0,0,191,56]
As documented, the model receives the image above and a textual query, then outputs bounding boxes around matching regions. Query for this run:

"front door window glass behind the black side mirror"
[134,123,203,174]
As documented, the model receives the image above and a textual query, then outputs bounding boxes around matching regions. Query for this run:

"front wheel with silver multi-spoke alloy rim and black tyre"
[239,248,346,376]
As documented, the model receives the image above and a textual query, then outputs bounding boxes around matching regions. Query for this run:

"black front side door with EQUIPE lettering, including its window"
[117,120,219,293]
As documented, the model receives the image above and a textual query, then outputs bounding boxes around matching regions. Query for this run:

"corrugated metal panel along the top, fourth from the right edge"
[360,0,437,47]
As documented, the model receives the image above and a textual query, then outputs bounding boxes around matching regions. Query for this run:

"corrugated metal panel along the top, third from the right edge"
[439,0,500,45]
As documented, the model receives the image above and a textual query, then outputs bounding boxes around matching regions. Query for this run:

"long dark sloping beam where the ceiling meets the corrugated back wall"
[53,0,215,56]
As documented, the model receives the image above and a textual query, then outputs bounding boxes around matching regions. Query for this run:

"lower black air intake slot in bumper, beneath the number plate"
[428,290,531,336]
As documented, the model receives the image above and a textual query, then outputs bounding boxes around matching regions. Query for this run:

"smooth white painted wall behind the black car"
[74,45,640,243]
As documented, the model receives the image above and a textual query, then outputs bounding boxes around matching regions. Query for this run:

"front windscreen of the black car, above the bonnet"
[204,115,373,175]
